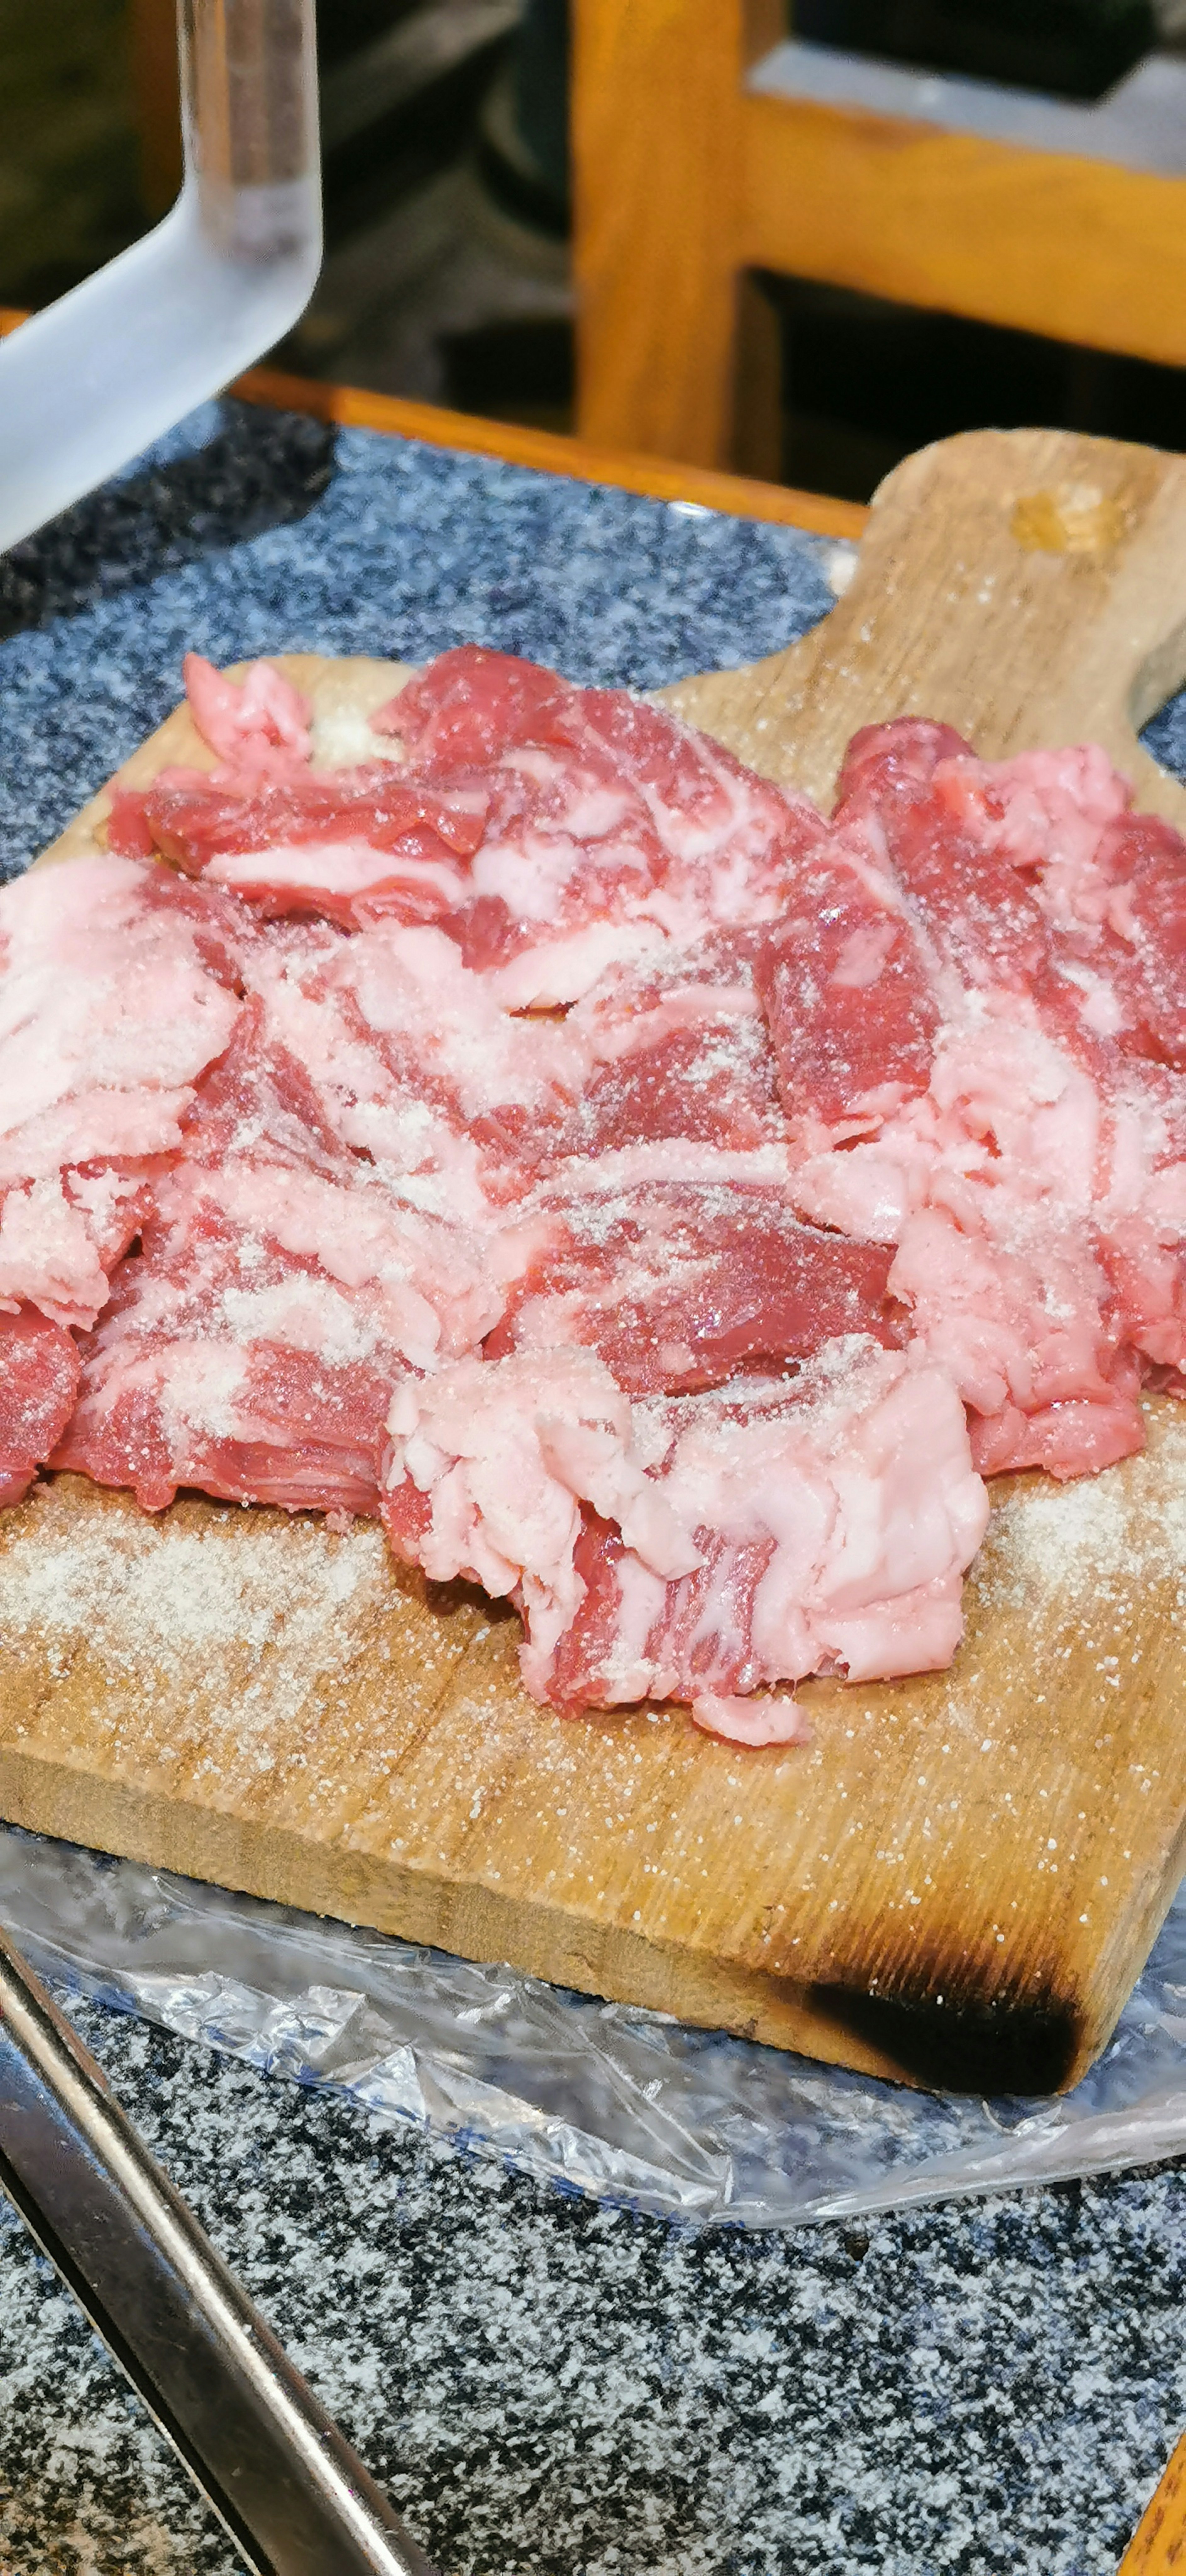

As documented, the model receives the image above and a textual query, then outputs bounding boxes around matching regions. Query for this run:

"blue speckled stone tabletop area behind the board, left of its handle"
[0,402,831,873]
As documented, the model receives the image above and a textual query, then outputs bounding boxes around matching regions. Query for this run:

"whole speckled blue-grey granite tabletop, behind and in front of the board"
[0,404,1186,2576]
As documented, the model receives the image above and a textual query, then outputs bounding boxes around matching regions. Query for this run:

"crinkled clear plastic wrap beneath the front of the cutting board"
[0,1826,1186,2228]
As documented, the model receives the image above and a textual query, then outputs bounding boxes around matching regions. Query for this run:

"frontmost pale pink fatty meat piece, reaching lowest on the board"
[383,1342,988,1726]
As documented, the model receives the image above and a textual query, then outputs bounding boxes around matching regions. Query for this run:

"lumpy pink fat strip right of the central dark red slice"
[792,1010,1142,1476]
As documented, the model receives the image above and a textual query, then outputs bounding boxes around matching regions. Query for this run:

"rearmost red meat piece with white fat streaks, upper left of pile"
[108,647,823,1010]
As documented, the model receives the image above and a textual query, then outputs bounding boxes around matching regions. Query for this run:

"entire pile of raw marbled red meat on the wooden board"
[18,649,1186,1744]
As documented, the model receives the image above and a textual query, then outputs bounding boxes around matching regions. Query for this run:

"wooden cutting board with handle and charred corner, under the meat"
[0,433,1186,2092]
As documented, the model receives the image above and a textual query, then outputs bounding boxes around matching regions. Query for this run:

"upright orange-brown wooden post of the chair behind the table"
[574,0,782,471]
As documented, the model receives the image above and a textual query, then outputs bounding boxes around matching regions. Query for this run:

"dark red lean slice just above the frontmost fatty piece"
[486,1175,901,1394]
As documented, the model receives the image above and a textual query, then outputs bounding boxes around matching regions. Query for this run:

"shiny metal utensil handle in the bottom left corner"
[0,1932,432,2576]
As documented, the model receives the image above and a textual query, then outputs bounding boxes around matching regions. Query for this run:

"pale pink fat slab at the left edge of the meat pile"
[0,858,239,1327]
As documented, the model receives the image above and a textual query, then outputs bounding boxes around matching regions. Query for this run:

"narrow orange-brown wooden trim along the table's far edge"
[0,307,869,538]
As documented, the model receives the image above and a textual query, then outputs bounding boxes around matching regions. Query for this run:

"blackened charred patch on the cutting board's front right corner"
[808,1976,1083,2094]
